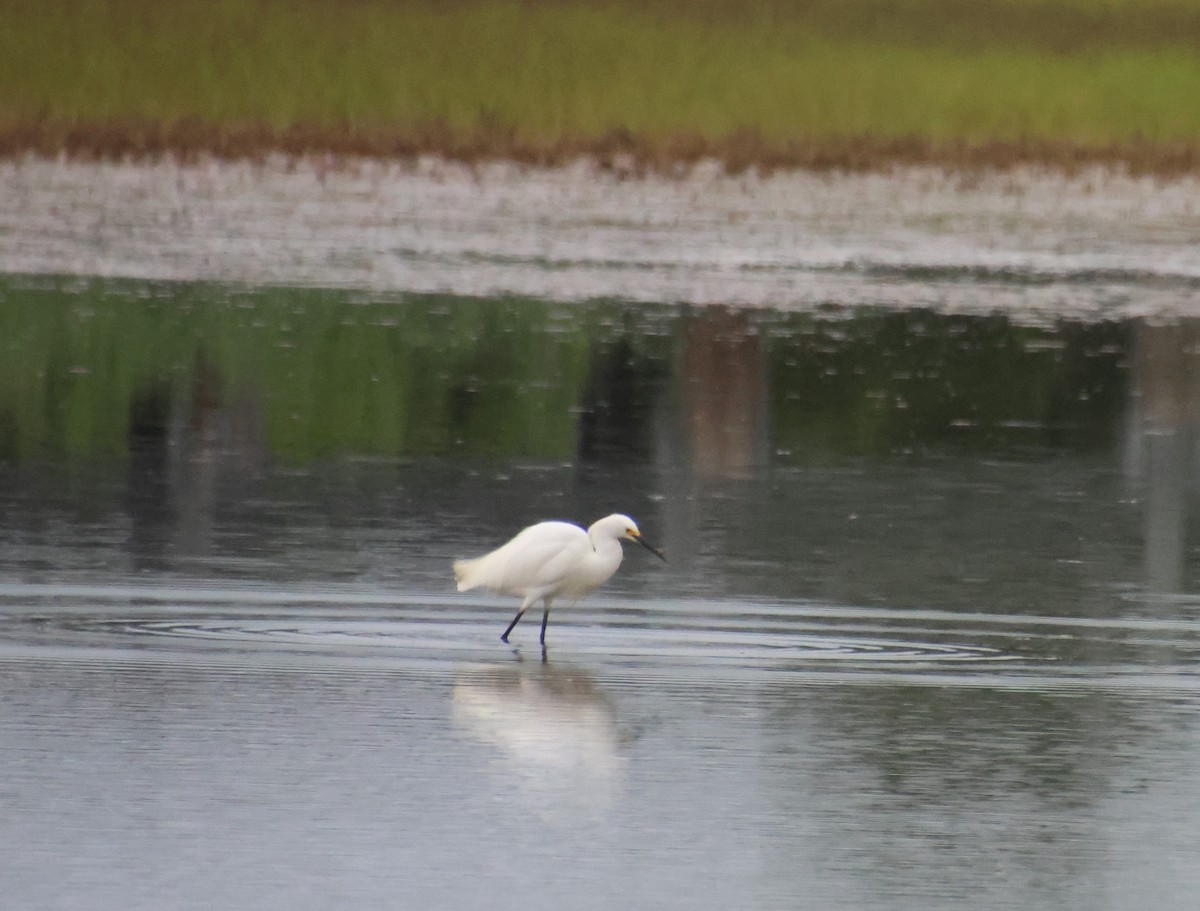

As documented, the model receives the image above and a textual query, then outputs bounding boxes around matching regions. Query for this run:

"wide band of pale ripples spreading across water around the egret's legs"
[0,586,1200,694]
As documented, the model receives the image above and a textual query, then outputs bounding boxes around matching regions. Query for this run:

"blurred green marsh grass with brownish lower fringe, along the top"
[0,0,1200,165]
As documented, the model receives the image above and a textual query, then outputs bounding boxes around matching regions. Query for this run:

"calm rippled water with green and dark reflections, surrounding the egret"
[0,160,1200,911]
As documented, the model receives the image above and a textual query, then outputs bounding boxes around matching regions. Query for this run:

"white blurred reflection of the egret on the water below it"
[452,659,630,819]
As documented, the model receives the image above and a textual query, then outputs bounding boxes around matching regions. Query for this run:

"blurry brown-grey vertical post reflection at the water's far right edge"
[1130,320,1200,592]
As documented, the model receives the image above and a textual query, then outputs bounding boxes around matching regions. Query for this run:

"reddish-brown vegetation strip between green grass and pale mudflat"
[7,119,1200,178]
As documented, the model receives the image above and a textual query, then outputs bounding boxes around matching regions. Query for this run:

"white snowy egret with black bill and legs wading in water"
[454,513,666,646]
